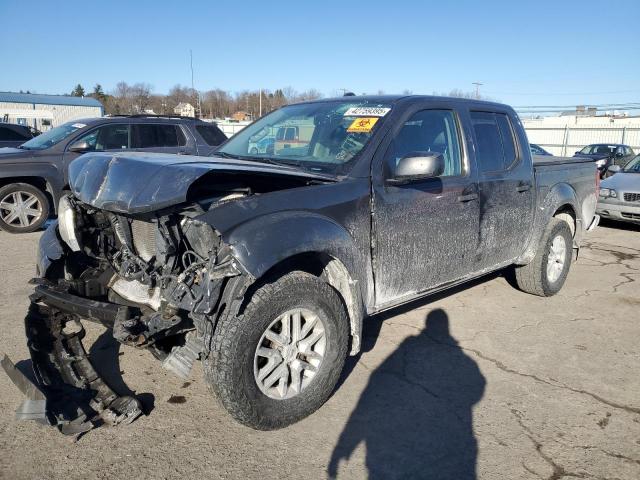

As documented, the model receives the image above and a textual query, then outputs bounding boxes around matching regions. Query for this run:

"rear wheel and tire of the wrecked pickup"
[515,218,573,297]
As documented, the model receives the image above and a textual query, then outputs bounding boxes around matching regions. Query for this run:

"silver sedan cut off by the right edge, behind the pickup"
[596,155,640,223]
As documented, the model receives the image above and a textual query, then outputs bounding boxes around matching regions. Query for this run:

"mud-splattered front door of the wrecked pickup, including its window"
[372,107,479,308]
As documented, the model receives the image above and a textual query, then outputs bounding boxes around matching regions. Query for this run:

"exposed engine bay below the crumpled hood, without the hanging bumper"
[58,192,244,360]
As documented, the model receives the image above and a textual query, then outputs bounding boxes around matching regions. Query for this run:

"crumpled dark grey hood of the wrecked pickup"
[69,152,333,213]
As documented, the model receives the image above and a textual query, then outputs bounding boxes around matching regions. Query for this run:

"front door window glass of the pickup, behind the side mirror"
[389,110,462,177]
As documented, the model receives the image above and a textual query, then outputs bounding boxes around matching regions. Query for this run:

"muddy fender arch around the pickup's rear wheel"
[515,183,582,265]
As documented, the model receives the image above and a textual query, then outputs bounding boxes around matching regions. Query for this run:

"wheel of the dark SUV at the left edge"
[0,183,51,233]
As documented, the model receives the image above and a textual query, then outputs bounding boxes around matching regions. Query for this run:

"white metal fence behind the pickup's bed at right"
[524,123,640,156]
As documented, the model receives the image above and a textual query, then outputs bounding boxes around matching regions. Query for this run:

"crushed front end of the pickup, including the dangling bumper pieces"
[2,193,250,434]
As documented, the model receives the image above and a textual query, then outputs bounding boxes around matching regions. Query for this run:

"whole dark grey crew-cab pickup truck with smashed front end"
[3,96,599,433]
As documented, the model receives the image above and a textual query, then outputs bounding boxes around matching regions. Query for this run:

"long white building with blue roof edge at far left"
[0,92,104,131]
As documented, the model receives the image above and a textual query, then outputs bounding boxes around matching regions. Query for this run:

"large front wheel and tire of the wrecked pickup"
[204,272,349,430]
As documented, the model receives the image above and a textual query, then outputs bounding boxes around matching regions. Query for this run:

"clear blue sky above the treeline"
[0,0,640,106]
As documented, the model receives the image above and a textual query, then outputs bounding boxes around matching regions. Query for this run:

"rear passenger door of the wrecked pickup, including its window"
[470,111,535,270]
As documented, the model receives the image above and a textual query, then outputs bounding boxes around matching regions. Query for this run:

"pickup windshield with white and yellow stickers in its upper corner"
[216,100,391,173]
